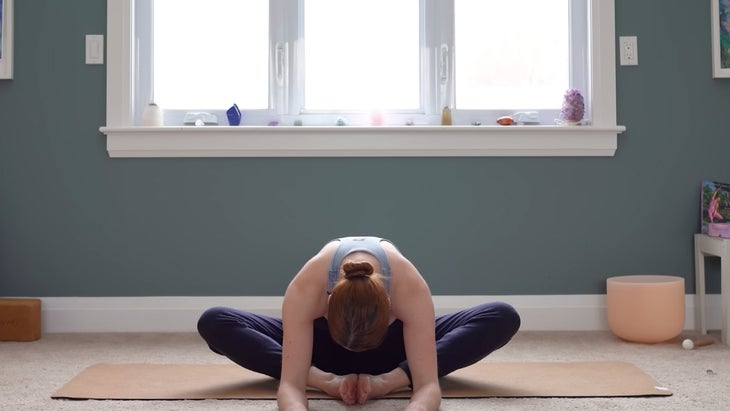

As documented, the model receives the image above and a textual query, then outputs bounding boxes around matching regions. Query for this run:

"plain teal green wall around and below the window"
[0,0,730,296]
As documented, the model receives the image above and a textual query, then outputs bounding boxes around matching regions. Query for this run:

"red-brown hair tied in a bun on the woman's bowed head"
[327,262,390,351]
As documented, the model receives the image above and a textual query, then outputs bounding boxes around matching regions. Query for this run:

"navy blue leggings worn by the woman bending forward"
[198,302,520,379]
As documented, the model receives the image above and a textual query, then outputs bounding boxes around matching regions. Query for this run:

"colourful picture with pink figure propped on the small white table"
[700,180,730,238]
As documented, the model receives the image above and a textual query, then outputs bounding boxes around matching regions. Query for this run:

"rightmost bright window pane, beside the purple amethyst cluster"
[454,0,570,110]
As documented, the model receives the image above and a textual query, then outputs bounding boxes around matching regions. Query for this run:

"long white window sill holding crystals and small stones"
[100,126,626,157]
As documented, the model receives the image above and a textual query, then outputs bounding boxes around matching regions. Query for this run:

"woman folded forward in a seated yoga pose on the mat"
[198,237,520,411]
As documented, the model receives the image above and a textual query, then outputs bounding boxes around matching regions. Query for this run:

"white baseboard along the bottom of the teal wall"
[41,294,722,333]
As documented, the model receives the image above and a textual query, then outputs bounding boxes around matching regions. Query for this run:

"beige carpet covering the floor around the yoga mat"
[0,331,730,411]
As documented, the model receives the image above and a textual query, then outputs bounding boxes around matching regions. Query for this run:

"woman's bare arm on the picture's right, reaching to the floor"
[389,248,441,411]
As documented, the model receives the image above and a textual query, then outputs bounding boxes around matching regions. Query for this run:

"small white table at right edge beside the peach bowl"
[695,234,730,344]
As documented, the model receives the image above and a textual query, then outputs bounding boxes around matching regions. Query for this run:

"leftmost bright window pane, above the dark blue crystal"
[154,0,269,109]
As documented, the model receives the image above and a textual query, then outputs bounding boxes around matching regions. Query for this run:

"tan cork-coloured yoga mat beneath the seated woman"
[52,361,672,400]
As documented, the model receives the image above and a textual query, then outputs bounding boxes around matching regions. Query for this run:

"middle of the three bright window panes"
[304,0,421,110]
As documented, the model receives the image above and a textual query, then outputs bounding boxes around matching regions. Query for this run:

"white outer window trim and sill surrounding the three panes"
[100,0,626,157]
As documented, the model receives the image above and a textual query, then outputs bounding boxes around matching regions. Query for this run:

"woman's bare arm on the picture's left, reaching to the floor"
[277,246,328,411]
